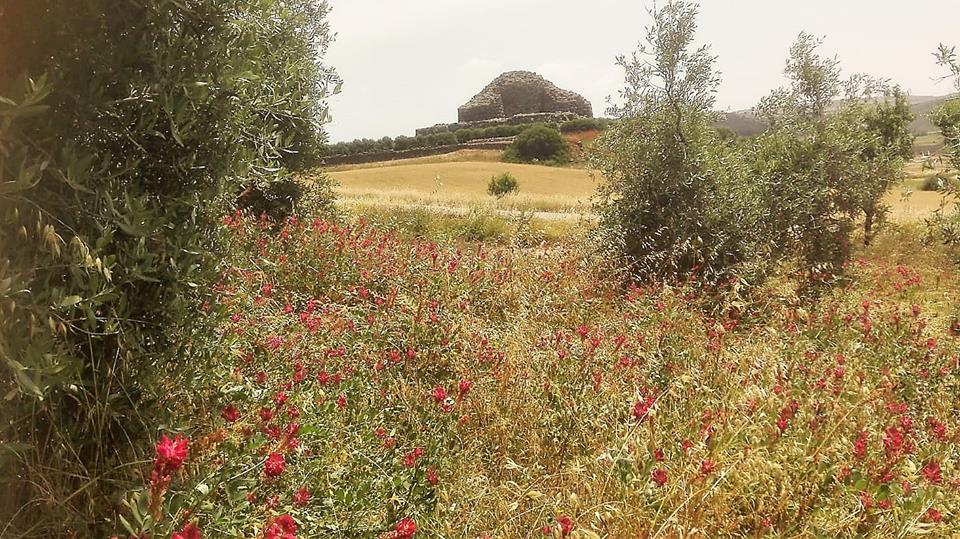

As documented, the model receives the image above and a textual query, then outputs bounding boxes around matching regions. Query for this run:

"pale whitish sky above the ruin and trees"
[325,0,960,142]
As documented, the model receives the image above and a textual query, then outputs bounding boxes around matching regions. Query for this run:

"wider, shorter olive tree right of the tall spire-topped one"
[753,33,913,274]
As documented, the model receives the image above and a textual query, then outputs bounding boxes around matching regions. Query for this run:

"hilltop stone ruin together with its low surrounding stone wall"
[417,71,593,135]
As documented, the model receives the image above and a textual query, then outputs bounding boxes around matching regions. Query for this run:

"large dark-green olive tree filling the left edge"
[0,0,336,537]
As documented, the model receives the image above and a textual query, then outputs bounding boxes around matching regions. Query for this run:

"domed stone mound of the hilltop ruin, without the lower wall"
[458,71,593,123]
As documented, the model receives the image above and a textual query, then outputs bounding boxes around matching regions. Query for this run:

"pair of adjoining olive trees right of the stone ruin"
[594,0,913,283]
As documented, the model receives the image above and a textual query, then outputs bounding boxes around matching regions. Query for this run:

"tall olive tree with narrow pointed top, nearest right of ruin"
[593,1,766,282]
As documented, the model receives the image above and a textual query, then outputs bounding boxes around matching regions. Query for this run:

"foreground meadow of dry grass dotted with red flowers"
[120,216,960,537]
